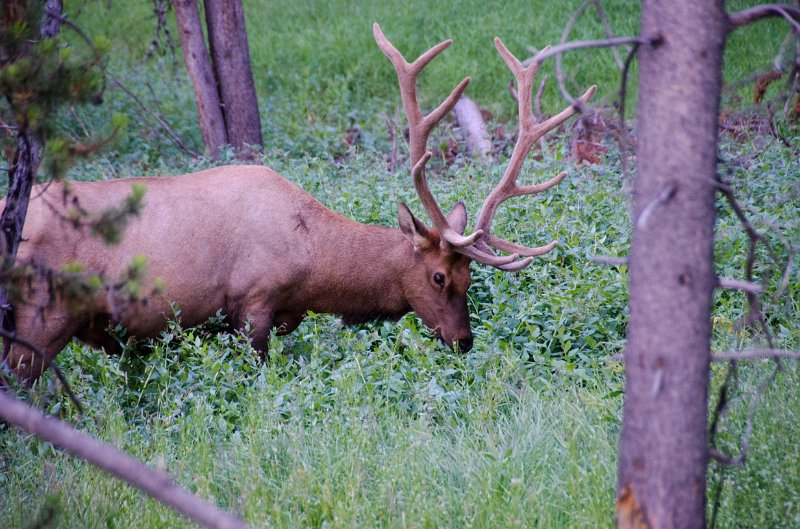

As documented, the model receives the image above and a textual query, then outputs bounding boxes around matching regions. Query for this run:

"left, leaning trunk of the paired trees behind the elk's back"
[172,0,228,158]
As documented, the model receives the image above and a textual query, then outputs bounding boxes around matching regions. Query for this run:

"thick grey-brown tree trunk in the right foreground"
[617,0,726,529]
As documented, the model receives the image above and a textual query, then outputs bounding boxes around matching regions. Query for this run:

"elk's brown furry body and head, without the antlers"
[3,166,472,381]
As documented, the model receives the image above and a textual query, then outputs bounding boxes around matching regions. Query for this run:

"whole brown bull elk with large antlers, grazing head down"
[4,24,595,382]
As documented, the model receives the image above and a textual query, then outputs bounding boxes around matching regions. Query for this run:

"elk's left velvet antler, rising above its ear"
[372,23,476,248]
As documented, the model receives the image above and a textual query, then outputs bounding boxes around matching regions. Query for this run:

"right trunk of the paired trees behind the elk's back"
[205,0,263,151]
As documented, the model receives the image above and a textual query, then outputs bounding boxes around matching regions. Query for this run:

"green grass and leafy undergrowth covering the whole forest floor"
[0,0,800,528]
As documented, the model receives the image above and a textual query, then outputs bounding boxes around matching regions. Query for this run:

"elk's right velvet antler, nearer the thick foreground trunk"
[475,37,597,270]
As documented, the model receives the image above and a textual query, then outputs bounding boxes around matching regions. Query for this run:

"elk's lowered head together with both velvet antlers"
[372,24,596,351]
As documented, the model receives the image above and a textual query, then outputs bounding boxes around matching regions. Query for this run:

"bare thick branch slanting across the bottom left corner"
[0,391,249,529]
